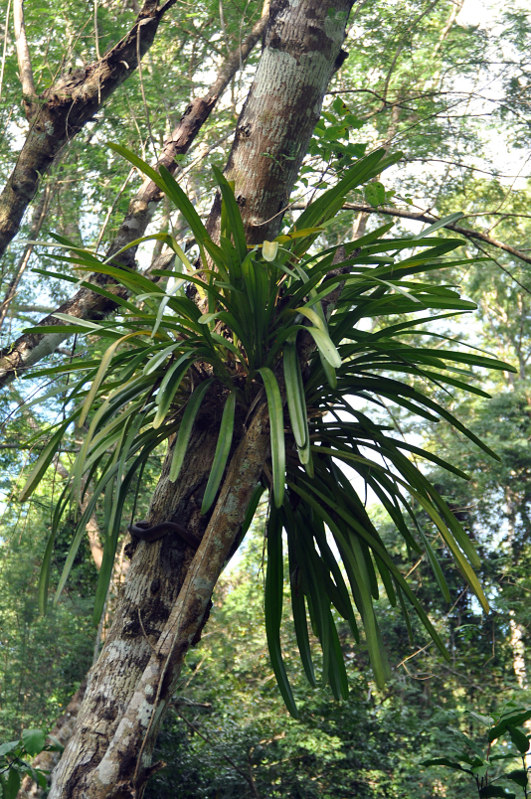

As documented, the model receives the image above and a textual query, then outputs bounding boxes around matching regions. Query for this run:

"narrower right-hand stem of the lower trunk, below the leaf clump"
[50,405,269,799]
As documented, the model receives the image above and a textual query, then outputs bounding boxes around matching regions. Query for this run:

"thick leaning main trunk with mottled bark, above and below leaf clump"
[45,0,352,799]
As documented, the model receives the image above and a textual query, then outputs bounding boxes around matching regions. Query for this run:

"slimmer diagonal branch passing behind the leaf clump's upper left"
[0,6,269,388]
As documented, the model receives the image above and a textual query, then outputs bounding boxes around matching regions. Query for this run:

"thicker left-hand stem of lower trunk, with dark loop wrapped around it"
[50,418,223,797]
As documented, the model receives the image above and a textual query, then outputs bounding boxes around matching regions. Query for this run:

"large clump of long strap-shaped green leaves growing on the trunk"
[22,145,506,714]
